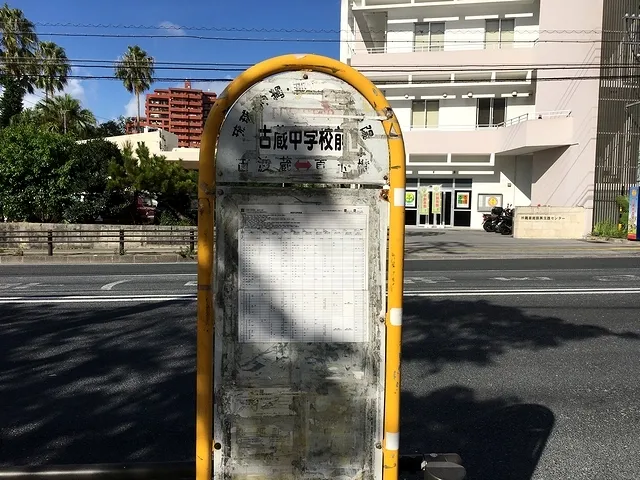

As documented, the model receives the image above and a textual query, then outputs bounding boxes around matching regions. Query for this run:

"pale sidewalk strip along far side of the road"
[0,227,640,265]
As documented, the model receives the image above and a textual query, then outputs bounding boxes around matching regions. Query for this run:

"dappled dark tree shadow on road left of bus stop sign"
[0,302,195,466]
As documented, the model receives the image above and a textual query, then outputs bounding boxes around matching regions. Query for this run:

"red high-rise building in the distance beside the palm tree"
[127,80,217,148]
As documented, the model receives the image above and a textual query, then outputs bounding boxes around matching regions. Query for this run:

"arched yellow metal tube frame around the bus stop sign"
[196,54,406,480]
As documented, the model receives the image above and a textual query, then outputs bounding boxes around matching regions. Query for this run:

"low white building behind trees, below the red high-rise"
[95,127,200,170]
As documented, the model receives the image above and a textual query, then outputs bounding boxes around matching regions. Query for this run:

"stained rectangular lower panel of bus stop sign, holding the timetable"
[214,186,387,480]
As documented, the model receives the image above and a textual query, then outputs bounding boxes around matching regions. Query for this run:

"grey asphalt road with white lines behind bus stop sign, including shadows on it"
[0,258,640,480]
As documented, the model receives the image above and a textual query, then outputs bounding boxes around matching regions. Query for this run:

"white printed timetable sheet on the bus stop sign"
[238,205,369,343]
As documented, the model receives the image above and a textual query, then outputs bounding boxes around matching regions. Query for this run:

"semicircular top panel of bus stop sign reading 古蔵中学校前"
[216,71,389,185]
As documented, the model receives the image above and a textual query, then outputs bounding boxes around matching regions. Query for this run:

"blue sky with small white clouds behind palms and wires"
[8,0,340,122]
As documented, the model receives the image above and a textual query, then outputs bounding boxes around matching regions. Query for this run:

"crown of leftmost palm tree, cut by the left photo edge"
[0,3,38,93]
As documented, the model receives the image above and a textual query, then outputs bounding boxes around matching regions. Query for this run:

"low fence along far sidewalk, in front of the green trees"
[0,227,198,256]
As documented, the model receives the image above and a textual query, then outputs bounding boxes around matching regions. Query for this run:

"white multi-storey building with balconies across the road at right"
[340,0,640,233]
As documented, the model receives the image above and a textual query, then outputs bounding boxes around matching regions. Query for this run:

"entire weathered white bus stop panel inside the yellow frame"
[214,71,396,480]
